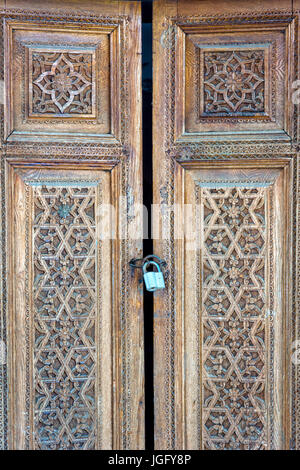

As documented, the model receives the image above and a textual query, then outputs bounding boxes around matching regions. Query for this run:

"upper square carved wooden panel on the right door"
[173,18,296,142]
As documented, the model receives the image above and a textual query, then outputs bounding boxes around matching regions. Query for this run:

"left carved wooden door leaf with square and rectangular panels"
[0,0,144,449]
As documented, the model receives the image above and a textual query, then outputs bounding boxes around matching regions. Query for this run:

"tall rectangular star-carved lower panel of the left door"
[9,163,113,449]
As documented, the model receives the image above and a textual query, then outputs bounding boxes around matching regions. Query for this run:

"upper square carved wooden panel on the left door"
[5,20,126,144]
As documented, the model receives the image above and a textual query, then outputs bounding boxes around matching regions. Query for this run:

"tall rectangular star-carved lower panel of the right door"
[178,163,289,450]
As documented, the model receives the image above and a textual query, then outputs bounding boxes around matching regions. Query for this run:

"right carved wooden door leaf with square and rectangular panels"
[153,0,300,449]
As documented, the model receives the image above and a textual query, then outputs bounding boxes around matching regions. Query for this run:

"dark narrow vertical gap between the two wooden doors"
[142,0,154,450]
